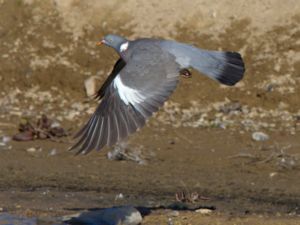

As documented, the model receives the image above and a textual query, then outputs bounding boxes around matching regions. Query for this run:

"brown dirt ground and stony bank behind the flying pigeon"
[0,0,300,225]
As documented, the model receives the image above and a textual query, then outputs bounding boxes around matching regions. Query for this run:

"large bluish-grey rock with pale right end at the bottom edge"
[62,206,143,225]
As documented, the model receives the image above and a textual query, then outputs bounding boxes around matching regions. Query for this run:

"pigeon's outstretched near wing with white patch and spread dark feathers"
[71,45,178,154]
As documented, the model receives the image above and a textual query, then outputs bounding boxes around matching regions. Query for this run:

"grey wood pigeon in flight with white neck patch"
[71,34,245,154]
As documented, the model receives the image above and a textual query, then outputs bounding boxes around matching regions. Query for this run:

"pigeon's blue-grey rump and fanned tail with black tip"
[162,41,245,86]
